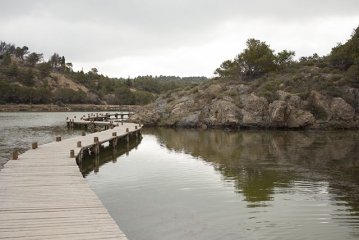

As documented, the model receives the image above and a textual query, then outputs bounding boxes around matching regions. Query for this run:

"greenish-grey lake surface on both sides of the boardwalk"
[0,113,359,239]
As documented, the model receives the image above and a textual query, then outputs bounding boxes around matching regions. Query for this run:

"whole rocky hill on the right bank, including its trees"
[132,25,359,129]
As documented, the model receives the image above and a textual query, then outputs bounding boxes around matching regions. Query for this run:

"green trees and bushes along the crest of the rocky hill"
[214,24,359,86]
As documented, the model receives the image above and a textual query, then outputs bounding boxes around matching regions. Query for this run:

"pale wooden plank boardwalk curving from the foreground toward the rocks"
[0,123,141,240]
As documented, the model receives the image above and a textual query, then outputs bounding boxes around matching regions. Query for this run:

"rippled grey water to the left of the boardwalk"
[0,112,121,170]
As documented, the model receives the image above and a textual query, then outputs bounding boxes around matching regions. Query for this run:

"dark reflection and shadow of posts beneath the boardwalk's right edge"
[79,137,142,177]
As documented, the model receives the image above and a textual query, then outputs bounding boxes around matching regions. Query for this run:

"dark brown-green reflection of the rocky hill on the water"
[146,128,359,209]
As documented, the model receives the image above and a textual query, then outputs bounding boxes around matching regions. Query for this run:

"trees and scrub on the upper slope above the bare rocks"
[208,24,359,111]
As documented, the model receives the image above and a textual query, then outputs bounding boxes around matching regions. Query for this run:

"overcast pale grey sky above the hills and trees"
[0,0,359,78]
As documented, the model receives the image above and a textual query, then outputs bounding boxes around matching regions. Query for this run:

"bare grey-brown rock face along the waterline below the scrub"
[132,84,359,129]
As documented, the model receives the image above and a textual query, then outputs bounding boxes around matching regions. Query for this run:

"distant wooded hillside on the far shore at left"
[0,41,207,105]
